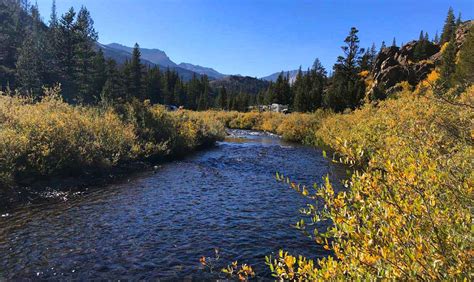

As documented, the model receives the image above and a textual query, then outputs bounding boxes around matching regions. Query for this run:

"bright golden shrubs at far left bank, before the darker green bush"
[0,87,135,182]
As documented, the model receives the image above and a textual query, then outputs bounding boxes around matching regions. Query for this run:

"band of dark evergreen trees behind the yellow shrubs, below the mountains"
[0,0,470,112]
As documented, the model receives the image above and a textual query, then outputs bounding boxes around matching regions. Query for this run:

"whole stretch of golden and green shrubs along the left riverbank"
[0,88,225,186]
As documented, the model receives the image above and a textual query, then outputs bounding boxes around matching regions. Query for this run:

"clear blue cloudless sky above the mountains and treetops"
[32,0,474,77]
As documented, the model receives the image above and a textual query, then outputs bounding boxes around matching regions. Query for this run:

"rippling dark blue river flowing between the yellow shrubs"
[0,130,344,280]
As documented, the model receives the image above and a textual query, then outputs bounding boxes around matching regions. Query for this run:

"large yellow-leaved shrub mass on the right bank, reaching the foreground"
[267,88,474,280]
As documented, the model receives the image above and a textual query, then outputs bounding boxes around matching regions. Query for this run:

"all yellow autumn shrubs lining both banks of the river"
[0,83,474,280]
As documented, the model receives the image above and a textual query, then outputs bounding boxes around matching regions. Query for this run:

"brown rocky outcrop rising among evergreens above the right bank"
[369,20,473,96]
